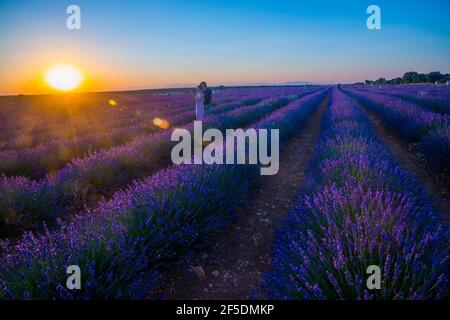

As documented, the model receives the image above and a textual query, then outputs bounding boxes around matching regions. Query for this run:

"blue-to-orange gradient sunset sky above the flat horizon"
[0,0,450,94]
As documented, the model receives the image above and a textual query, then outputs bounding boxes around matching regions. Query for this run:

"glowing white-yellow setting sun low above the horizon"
[45,65,83,91]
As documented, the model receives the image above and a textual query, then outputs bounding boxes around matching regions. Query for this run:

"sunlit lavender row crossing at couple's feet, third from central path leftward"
[0,88,299,178]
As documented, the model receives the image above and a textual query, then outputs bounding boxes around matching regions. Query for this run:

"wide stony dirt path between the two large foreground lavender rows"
[162,96,329,300]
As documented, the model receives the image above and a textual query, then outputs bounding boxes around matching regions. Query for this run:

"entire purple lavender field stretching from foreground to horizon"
[0,85,450,300]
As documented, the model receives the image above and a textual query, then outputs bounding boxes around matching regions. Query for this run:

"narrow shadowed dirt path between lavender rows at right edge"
[349,96,450,220]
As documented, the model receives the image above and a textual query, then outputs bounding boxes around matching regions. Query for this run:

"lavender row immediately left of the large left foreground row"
[0,89,317,237]
